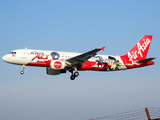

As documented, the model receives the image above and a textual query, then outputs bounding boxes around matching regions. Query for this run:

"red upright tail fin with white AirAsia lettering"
[122,35,153,64]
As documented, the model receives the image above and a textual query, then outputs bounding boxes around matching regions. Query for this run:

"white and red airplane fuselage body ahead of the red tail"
[2,49,127,71]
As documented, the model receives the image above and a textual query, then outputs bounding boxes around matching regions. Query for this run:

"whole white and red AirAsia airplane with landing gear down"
[2,35,155,80]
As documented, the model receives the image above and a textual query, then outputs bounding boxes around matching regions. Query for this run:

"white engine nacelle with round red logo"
[50,60,66,70]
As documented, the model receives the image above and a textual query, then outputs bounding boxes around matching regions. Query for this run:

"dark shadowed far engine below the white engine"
[46,67,66,75]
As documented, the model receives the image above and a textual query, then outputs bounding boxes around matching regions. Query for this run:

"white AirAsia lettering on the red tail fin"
[128,38,151,64]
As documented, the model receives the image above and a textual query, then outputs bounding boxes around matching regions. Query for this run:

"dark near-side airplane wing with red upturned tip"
[66,47,105,64]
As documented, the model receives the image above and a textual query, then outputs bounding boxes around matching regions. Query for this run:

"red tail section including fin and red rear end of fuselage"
[121,35,155,68]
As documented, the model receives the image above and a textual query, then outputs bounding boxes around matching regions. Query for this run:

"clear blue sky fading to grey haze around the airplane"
[0,0,160,120]
